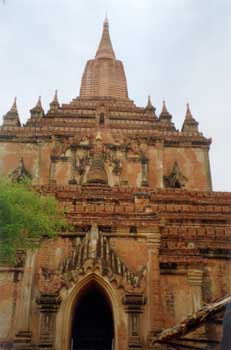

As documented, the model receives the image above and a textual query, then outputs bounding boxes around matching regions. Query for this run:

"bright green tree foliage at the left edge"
[0,178,67,263]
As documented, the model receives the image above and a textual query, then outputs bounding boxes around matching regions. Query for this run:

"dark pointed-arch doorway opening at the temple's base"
[71,286,114,350]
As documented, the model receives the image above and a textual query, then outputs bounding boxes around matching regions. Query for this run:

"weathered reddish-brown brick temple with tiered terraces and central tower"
[0,19,231,350]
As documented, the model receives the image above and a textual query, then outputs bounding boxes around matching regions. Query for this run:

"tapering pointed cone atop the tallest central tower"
[95,14,115,59]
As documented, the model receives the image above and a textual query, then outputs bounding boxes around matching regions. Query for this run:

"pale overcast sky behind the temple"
[0,0,231,191]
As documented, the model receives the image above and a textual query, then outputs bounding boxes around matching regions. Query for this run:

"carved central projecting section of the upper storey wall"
[50,132,152,186]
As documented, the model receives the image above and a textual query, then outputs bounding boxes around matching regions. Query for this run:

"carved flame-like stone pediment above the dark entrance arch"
[39,224,146,293]
